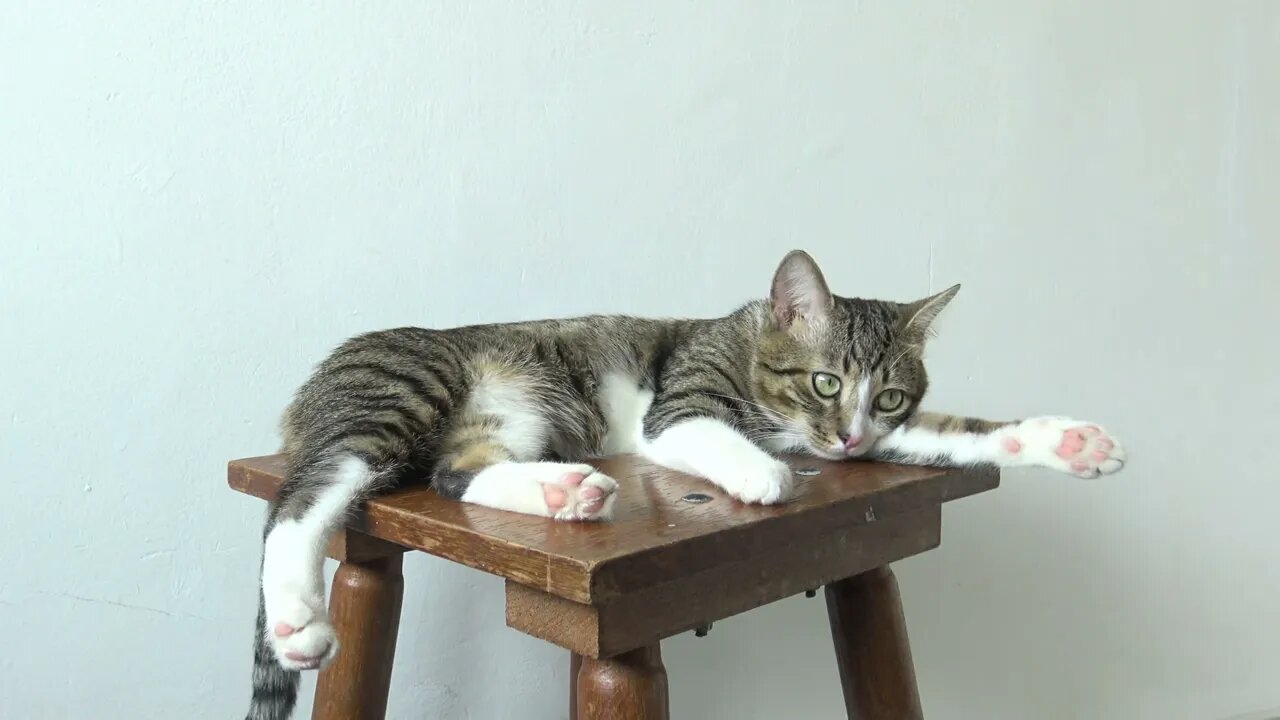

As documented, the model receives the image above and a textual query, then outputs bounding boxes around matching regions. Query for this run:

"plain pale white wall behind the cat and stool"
[0,0,1280,720]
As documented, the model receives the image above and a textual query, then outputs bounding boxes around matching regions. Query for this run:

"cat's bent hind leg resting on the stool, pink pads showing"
[431,373,618,520]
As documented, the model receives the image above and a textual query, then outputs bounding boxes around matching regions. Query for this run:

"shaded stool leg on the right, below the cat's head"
[827,566,924,720]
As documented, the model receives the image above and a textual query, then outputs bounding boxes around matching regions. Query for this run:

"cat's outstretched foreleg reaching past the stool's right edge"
[869,413,1125,478]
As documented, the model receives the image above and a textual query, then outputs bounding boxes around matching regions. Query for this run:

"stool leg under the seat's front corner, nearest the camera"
[576,643,671,720]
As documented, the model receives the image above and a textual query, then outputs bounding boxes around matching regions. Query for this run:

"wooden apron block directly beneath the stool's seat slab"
[506,506,942,657]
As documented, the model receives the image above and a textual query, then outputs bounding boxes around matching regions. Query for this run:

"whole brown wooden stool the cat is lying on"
[228,456,1000,720]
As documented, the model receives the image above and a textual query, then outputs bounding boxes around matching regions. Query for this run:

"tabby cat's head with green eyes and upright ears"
[751,250,960,460]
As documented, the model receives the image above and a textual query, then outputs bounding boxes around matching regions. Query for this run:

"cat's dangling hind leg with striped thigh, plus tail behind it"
[248,353,453,702]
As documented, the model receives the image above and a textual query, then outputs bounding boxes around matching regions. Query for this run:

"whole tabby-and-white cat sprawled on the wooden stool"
[248,250,1125,720]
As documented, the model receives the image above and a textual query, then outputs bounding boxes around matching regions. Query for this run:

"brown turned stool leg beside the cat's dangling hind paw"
[311,553,404,720]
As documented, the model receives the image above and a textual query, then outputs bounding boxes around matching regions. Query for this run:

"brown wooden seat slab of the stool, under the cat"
[228,455,1000,589]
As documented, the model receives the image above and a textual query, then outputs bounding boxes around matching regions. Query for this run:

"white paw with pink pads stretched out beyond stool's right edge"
[1000,418,1126,478]
